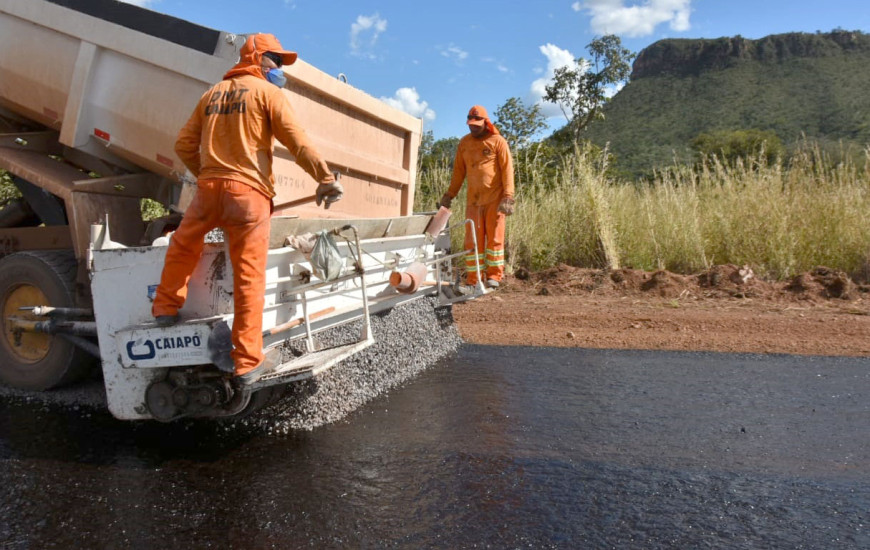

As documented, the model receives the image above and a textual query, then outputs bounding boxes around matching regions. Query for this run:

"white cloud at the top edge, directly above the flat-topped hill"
[571,0,692,36]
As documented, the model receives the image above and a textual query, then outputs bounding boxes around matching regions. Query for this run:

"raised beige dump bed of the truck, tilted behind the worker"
[0,0,422,218]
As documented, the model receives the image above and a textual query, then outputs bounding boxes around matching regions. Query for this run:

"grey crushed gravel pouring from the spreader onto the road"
[234,297,462,433]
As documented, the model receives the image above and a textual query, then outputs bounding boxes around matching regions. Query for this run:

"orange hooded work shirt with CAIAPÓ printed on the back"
[175,40,335,198]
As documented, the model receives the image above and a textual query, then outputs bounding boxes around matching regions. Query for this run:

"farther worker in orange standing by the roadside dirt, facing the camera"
[441,105,514,288]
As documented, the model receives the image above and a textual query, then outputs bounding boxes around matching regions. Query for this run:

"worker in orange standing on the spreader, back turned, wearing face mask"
[151,34,343,385]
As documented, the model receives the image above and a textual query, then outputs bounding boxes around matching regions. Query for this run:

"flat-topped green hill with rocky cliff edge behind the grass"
[585,30,870,174]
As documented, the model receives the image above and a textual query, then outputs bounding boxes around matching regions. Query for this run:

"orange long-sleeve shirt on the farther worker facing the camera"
[447,134,514,206]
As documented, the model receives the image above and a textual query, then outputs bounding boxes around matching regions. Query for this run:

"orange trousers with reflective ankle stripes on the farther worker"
[465,200,507,285]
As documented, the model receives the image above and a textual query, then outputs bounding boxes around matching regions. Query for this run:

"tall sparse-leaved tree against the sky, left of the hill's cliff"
[544,34,635,141]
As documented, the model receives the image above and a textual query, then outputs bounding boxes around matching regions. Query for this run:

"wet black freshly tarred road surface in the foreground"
[0,345,870,549]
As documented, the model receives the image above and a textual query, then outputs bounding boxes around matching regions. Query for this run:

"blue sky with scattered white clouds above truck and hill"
[119,0,870,139]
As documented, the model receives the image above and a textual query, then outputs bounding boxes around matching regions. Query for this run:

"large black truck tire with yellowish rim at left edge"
[0,251,94,391]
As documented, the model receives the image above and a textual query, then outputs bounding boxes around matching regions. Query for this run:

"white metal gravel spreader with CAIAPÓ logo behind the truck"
[90,215,483,420]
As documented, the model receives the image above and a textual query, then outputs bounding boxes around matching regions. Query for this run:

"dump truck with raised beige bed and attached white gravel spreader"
[0,0,483,421]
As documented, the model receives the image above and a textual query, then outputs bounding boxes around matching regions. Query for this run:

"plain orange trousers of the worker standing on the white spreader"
[151,179,272,375]
